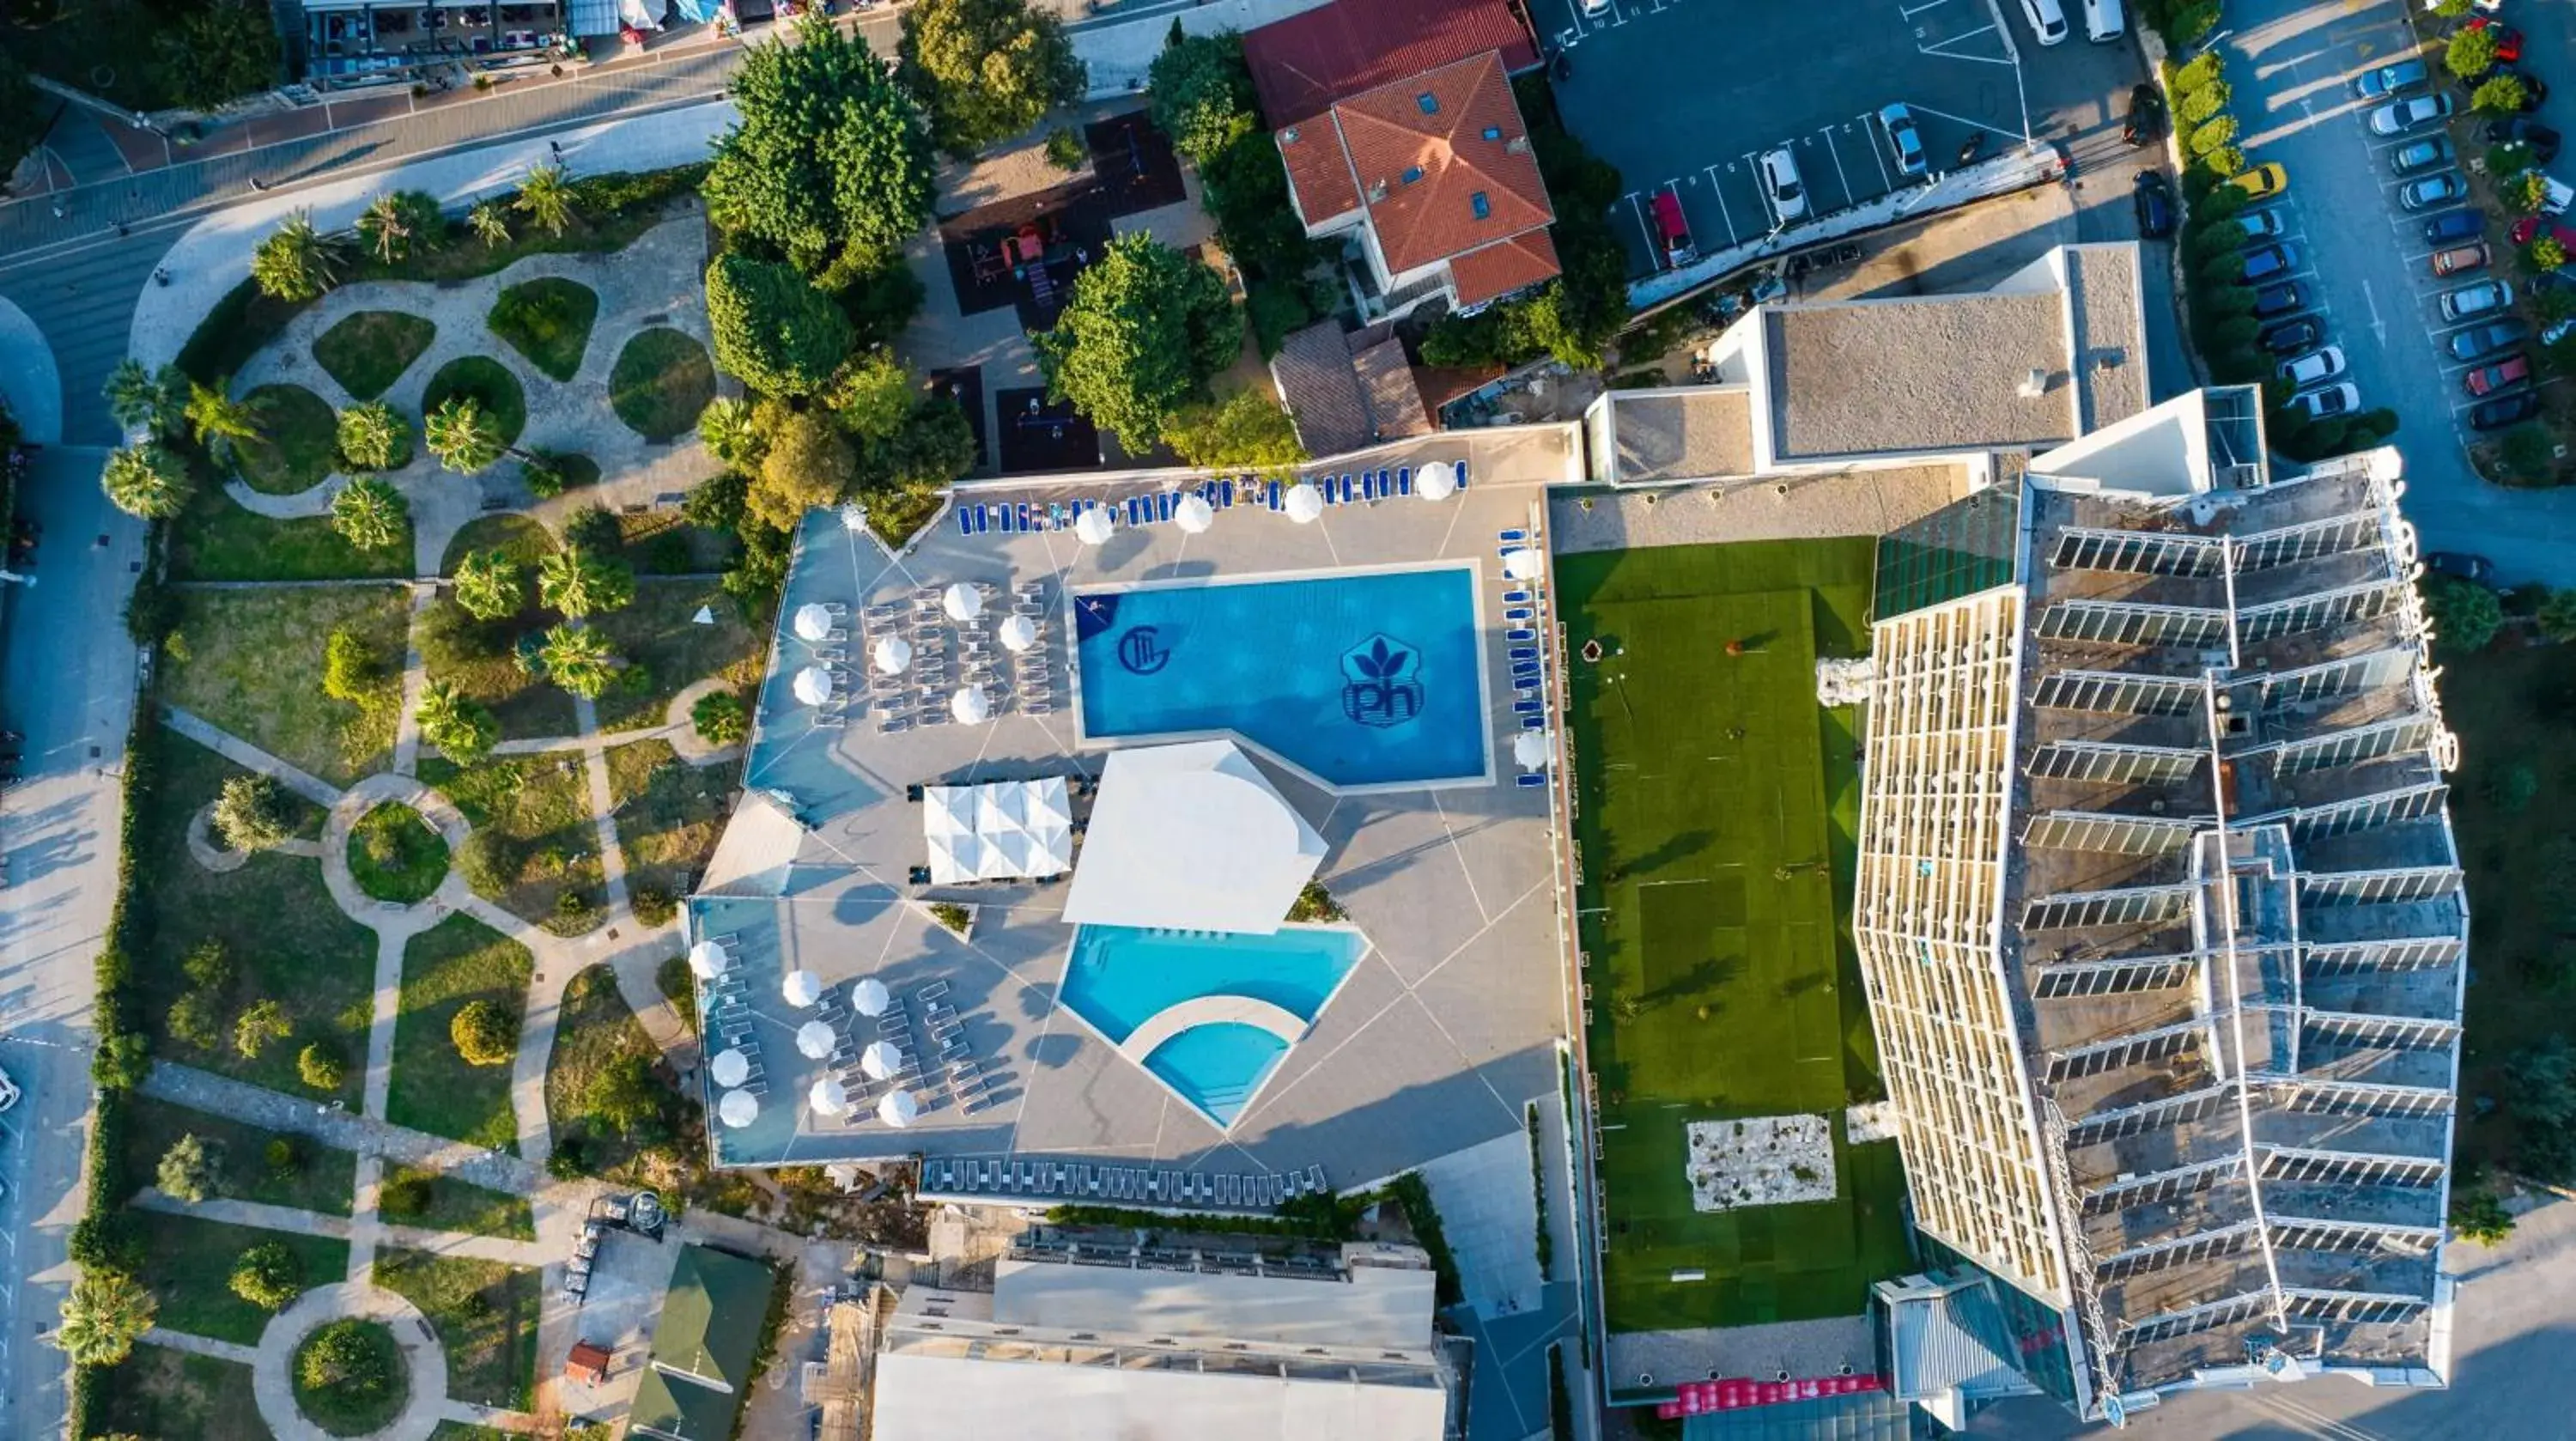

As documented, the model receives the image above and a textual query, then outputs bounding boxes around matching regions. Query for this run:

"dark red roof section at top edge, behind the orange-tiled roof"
[1244,0,1538,129]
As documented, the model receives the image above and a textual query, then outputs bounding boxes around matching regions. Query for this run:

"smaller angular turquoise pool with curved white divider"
[1059,926,1368,1129]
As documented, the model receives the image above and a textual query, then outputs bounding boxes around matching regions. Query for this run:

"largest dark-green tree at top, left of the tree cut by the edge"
[706,10,933,276]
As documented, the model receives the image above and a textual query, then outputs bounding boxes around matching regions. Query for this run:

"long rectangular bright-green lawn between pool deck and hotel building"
[1558,538,1909,1330]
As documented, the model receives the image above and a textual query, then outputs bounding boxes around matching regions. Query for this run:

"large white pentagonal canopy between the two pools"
[1064,740,1324,936]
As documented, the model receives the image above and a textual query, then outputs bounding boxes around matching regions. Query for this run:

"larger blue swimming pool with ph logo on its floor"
[1074,567,1486,787]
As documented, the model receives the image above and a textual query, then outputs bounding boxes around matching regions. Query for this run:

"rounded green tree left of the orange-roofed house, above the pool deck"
[1030,232,1244,453]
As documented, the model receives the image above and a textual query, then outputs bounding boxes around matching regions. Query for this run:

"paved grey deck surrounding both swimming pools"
[690,430,1569,1186]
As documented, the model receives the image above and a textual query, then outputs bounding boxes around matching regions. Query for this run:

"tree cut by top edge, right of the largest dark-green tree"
[896,0,1090,160]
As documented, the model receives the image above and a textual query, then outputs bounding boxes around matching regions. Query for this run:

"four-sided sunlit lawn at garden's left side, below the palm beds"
[160,585,412,787]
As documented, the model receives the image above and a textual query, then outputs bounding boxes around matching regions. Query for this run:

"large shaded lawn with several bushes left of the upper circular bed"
[129,730,376,1101]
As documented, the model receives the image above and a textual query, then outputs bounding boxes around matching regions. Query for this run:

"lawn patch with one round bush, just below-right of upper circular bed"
[386,915,536,1152]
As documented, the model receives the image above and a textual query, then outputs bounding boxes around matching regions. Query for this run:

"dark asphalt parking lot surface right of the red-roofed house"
[1530,0,2030,276]
